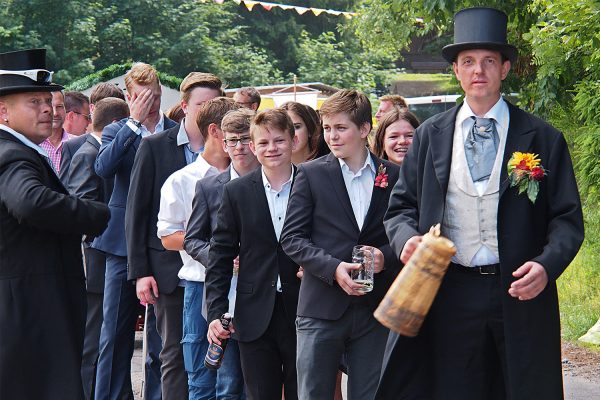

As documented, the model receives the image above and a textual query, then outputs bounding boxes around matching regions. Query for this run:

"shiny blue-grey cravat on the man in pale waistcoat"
[465,117,500,182]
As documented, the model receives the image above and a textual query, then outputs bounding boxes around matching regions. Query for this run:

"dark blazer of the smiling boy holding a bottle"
[205,168,300,342]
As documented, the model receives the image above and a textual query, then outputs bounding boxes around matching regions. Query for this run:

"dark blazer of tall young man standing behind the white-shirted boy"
[125,125,186,294]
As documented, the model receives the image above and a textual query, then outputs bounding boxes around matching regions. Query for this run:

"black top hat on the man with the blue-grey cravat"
[442,7,517,63]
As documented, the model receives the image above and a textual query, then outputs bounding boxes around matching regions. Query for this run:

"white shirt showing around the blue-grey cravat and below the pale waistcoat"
[454,97,510,266]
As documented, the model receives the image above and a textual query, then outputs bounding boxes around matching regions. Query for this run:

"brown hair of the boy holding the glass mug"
[319,89,373,130]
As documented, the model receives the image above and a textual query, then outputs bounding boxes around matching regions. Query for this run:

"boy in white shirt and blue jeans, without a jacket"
[156,97,237,399]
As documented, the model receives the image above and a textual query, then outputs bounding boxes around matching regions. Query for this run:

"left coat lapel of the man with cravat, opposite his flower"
[429,105,460,197]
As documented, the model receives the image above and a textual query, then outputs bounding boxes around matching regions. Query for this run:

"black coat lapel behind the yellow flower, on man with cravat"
[499,102,535,197]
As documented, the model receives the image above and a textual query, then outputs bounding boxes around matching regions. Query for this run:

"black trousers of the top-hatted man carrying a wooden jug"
[424,264,508,400]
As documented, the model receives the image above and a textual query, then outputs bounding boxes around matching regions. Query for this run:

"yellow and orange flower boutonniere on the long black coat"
[508,151,547,204]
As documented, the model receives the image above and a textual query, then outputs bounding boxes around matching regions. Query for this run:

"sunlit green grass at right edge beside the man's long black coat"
[557,206,600,344]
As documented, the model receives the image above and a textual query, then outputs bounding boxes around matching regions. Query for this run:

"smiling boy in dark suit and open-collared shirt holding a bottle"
[206,109,300,400]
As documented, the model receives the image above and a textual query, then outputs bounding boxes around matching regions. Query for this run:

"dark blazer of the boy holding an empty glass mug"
[281,154,400,320]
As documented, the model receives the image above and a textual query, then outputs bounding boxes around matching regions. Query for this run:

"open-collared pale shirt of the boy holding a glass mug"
[338,150,376,229]
